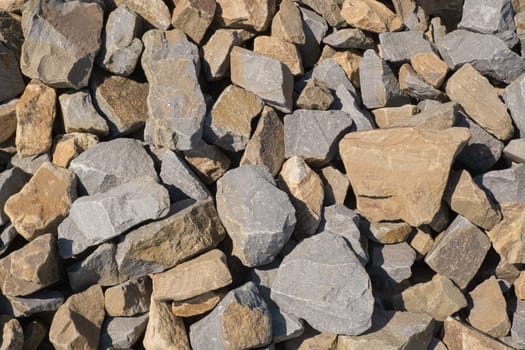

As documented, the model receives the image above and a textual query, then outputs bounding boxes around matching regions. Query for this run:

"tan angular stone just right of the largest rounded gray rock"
[394,274,467,321]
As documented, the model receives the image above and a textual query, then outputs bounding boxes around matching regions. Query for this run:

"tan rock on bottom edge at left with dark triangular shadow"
[49,285,104,350]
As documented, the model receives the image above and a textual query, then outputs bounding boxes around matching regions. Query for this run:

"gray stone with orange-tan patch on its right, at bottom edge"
[190,282,272,350]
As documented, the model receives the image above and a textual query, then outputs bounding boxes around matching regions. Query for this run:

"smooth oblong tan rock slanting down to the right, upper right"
[446,64,514,141]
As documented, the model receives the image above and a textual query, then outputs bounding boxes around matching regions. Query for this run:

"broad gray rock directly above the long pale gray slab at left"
[69,138,157,195]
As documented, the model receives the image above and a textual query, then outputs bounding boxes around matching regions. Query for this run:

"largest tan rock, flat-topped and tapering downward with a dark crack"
[339,128,470,227]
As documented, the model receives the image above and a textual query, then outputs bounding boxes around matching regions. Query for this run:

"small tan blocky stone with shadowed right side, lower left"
[104,276,152,317]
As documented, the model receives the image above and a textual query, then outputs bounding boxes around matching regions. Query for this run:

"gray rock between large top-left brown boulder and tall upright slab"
[97,3,144,76]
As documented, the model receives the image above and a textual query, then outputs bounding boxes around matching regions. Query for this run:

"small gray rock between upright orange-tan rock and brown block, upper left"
[58,90,109,135]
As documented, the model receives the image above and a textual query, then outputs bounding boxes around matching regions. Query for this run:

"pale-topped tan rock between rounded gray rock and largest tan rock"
[277,156,324,235]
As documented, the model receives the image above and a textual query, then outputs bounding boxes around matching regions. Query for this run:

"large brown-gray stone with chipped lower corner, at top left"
[20,1,103,89]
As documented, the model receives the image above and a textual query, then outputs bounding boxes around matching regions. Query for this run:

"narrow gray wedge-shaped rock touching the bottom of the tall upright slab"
[160,150,211,203]
